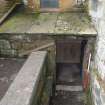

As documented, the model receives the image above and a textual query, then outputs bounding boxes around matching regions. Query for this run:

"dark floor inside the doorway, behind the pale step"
[56,63,82,85]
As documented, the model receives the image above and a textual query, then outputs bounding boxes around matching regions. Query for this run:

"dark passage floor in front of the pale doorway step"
[50,91,84,105]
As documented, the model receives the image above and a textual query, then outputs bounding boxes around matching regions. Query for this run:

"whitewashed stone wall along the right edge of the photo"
[89,0,105,105]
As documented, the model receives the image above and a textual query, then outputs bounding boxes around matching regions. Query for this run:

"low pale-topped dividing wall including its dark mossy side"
[0,51,53,105]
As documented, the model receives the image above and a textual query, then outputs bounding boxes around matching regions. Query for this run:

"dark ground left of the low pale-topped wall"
[0,58,25,100]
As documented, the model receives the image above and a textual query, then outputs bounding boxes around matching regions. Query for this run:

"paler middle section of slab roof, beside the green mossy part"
[27,13,58,34]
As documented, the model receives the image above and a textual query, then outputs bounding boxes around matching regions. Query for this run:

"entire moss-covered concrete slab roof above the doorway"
[0,6,97,36]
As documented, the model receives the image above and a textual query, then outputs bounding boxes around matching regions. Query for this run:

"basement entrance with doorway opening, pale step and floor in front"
[51,39,86,105]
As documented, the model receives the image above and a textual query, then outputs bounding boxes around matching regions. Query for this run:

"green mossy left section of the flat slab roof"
[0,13,40,32]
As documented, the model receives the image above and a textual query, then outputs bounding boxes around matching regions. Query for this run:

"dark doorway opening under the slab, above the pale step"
[56,39,84,85]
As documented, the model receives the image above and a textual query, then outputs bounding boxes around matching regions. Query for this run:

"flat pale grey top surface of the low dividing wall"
[0,51,46,105]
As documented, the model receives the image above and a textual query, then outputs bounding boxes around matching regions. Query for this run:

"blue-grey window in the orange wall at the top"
[40,0,59,8]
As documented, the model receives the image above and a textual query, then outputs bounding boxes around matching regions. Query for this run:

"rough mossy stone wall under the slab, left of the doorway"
[0,35,54,57]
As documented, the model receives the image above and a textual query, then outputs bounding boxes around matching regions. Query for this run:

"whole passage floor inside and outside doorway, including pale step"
[50,64,85,105]
